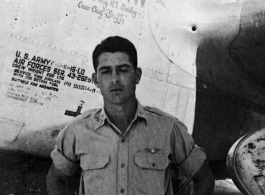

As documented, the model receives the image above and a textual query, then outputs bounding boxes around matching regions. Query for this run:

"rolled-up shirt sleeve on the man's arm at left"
[51,126,79,176]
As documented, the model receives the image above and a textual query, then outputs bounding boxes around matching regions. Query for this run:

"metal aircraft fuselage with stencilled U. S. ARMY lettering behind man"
[0,0,265,194]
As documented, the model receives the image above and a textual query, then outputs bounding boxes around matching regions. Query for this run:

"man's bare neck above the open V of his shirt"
[104,97,137,134]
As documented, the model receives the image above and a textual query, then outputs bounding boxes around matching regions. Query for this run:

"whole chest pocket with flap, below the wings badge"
[134,152,169,195]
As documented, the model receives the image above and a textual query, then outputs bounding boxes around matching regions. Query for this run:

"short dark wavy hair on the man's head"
[92,36,137,71]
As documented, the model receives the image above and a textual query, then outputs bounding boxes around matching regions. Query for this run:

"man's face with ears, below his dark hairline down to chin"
[93,52,141,103]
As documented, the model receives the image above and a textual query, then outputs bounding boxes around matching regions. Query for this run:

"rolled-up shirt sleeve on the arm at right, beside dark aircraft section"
[170,121,206,178]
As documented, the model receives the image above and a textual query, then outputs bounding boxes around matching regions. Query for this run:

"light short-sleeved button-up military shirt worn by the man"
[51,102,206,195]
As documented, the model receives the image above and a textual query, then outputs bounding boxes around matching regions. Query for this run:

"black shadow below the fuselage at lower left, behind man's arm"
[0,150,80,195]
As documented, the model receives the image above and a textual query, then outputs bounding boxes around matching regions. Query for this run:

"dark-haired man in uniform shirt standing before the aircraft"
[47,37,214,195]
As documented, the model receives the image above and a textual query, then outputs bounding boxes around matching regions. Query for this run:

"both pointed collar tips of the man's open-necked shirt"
[95,100,147,129]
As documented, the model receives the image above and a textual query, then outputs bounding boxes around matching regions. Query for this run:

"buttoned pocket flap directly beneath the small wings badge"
[134,152,169,170]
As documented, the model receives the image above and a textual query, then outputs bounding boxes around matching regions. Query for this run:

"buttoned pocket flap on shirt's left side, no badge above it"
[80,154,110,170]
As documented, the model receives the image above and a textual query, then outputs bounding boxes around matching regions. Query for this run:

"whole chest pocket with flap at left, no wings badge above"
[80,154,110,195]
